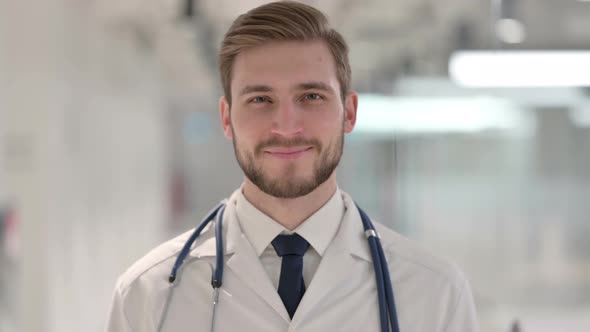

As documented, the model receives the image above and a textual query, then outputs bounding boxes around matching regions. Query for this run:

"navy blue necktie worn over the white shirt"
[271,234,309,318]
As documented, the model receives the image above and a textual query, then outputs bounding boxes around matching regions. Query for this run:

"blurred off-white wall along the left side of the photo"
[0,0,167,332]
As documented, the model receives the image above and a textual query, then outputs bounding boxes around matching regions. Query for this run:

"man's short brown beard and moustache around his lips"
[232,123,344,198]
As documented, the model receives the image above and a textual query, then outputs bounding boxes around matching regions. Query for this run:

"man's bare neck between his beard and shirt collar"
[242,174,337,231]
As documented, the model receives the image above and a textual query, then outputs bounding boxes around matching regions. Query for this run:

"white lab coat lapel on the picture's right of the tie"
[293,194,371,325]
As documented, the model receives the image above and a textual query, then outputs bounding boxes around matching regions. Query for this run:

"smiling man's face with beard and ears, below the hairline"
[221,41,357,198]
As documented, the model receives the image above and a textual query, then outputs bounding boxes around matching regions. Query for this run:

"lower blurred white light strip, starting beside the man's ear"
[355,94,534,135]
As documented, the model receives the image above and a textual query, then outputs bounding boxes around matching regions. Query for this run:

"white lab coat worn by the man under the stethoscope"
[106,193,478,332]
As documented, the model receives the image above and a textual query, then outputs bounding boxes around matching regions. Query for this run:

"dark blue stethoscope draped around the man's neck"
[158,201,399,332]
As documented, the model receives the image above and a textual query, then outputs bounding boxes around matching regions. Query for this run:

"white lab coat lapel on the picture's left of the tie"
[224,198,291,322]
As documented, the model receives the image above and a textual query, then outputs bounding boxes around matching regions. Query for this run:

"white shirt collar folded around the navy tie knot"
[236,188,344,256]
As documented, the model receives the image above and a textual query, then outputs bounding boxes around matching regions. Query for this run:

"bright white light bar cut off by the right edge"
[449,51,590,87]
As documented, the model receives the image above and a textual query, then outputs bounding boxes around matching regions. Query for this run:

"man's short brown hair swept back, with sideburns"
[219,1,351,105]
